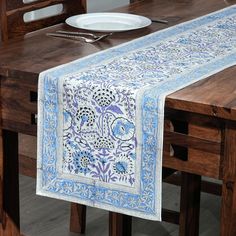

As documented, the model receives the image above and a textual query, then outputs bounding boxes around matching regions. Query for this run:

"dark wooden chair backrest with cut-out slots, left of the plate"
[0,0,86,41]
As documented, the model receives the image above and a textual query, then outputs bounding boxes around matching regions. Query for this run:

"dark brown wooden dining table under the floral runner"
[0,0,236,236]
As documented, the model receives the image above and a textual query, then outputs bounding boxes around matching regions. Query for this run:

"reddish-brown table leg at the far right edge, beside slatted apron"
[220,124,236,236]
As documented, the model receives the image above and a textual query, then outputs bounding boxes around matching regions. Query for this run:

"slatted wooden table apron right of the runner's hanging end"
[163,108,224,178]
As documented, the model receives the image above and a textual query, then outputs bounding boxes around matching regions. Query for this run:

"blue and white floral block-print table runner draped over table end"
[37,5,236,220]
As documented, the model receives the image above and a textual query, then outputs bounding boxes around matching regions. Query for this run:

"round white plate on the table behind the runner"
[66,13,152,32]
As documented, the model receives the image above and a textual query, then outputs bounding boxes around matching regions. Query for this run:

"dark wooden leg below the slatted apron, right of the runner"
[179,172,201,236]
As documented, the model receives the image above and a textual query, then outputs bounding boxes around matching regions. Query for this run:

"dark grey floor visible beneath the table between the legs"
[20,176,221,236]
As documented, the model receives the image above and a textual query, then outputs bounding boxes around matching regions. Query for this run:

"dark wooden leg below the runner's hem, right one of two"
[109,212,132,236]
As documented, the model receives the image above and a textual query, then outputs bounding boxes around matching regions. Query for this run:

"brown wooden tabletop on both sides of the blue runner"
[0,0,236,120]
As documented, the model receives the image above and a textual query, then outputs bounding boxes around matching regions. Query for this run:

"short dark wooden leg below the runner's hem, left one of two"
[70,203,86,234]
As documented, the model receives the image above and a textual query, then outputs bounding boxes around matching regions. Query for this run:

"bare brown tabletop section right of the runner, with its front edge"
[166,66,236,121]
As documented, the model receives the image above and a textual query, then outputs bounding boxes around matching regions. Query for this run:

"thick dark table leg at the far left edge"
[0,130,20,236]
